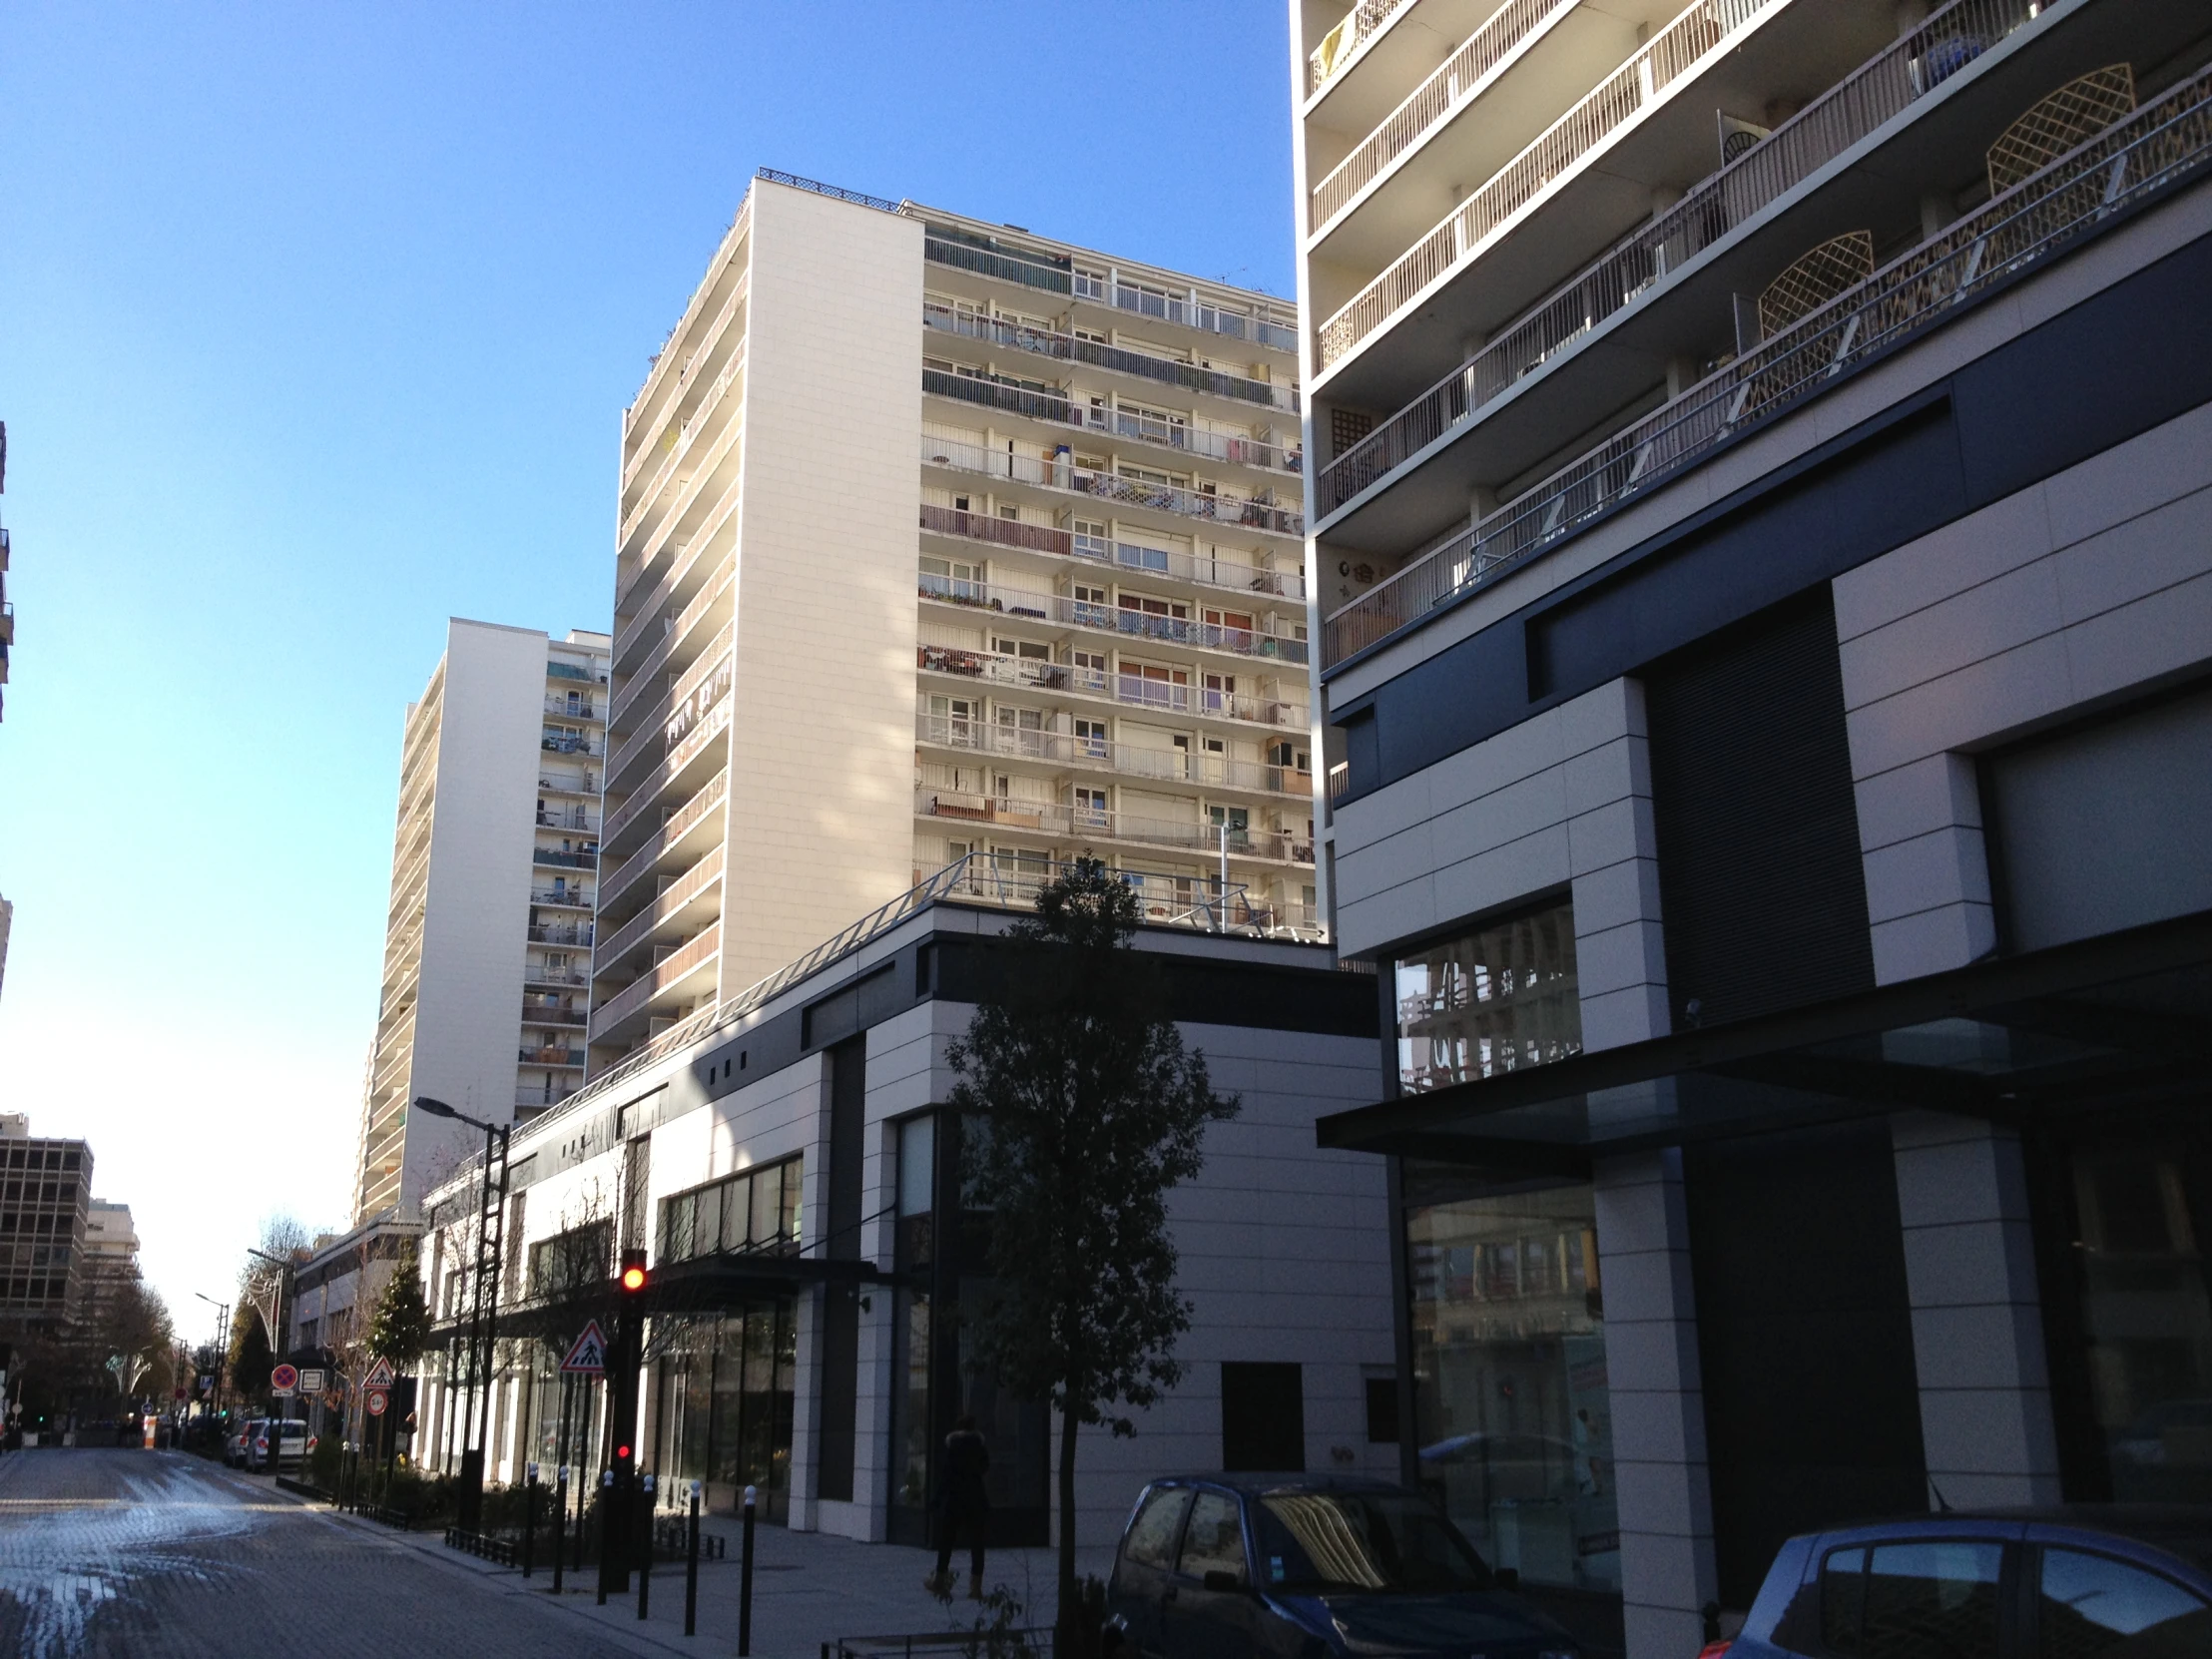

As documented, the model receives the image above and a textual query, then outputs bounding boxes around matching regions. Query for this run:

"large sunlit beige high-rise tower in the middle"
[591,173,1314,1066]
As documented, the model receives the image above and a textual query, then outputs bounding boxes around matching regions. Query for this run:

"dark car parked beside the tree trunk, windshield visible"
[1106,1475,1579,1659]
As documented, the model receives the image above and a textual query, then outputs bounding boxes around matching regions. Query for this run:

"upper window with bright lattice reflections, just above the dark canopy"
[1395,904,1581,1093]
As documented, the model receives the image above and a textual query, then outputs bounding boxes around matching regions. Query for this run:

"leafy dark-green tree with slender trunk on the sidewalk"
[946,858,1237,1655]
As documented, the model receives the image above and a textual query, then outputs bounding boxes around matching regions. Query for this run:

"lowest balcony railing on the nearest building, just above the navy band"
[1323,60,2212,666]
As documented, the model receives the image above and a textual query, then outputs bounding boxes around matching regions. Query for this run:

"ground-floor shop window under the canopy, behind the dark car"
[1404,1161,1621,1590]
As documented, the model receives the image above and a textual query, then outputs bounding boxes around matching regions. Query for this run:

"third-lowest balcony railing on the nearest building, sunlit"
[1319,0,1783,367]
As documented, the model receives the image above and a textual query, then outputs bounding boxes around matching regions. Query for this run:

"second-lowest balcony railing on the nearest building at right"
[1314,0,2037,513]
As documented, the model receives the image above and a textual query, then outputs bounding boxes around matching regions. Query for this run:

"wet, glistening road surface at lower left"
[0,1448,639,1659]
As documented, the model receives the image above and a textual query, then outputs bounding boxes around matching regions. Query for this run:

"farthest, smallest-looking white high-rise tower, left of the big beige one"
[354,617,611,1221]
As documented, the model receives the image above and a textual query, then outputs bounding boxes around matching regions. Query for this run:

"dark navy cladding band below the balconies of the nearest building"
[1332,237,2212,814]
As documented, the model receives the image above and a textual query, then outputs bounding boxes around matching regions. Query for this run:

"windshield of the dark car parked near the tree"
[1257,1491,1493,1593]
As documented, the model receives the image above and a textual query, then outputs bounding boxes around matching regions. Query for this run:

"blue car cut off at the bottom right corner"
[1686,1504,2212,1659]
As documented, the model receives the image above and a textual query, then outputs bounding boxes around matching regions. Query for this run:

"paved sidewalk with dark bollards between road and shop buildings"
[282,1480,1113,1659]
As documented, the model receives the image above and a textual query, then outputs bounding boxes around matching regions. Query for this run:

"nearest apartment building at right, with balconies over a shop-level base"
[1290,0,2212,1659]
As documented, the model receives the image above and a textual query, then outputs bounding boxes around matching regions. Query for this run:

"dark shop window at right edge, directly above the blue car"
[2072,1137,2212,1504]
